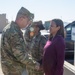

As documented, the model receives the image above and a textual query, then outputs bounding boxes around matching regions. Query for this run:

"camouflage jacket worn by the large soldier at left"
[1,22,34,74]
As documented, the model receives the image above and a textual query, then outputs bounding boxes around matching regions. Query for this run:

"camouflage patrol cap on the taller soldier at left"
[17,7,34,20]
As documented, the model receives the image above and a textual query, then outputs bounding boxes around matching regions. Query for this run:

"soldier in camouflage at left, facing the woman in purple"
[1,7,36,75]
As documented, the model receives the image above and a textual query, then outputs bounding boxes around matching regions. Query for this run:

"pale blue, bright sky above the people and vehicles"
[0,0,75,22]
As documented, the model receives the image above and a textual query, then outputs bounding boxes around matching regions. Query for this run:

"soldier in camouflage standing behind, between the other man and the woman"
[24,21,47,75]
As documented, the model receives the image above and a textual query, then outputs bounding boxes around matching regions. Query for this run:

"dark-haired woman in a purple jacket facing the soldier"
[43,19,65,75]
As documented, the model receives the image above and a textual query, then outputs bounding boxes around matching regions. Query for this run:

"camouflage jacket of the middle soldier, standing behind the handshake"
[24,27,47,61]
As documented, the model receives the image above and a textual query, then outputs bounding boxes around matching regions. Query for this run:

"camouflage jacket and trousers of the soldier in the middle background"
[24,27,47,75]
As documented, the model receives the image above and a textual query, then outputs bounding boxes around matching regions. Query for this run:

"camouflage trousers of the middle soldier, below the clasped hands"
[26,65,44,75]
